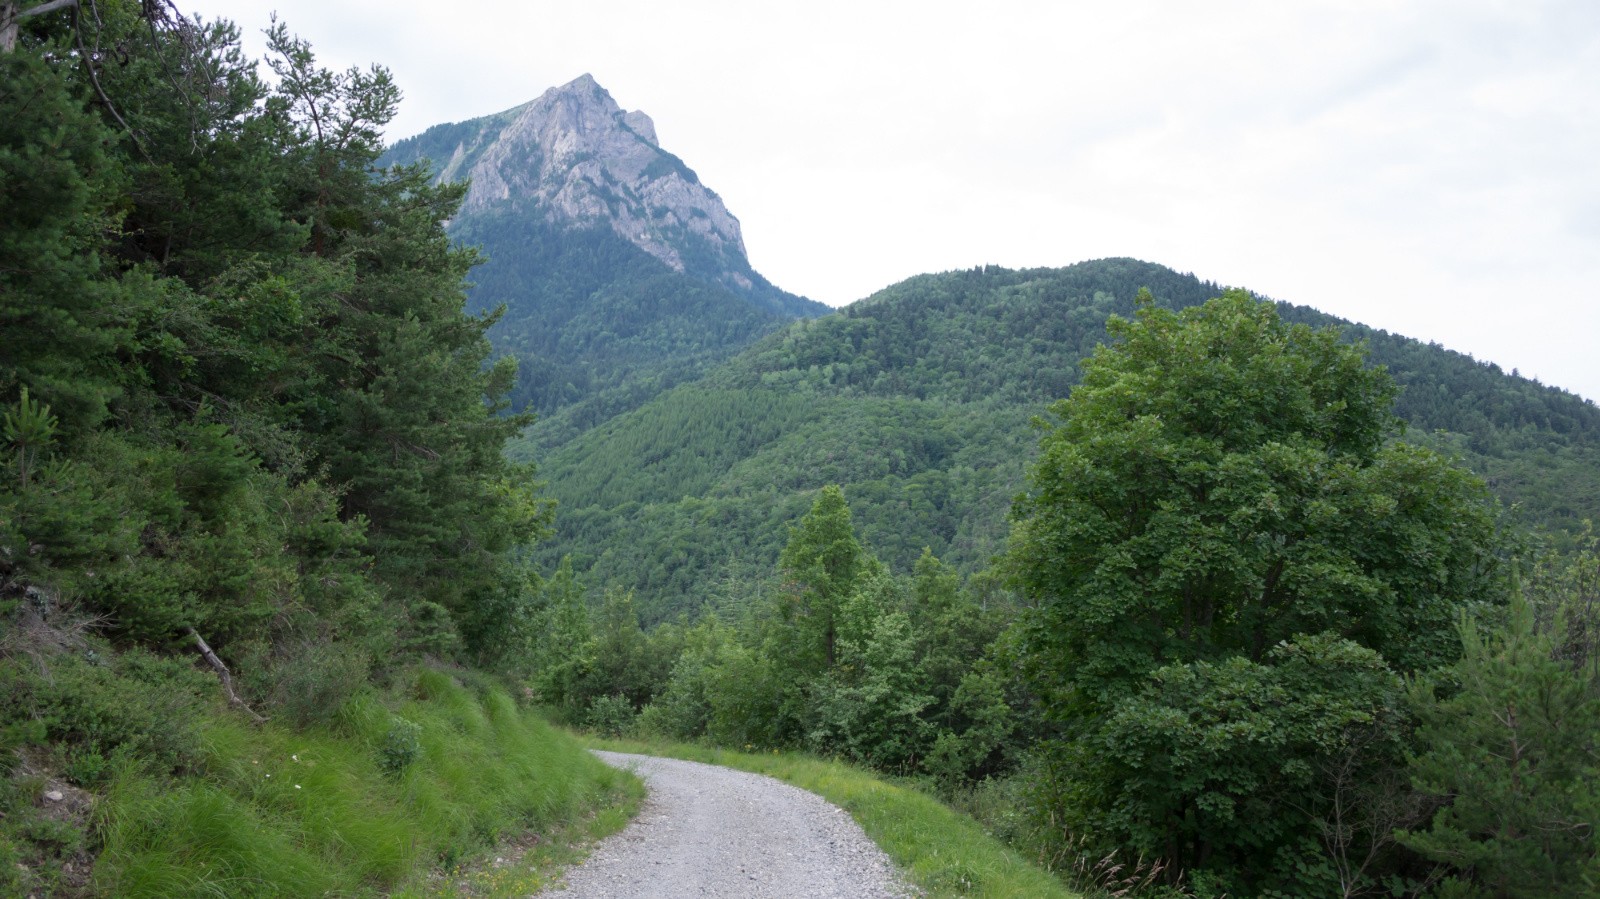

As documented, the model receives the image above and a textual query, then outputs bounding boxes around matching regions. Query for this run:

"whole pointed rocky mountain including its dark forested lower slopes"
[379,75,827,419]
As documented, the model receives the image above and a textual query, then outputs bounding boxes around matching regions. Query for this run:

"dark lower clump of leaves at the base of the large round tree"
[1100,635,1402,893]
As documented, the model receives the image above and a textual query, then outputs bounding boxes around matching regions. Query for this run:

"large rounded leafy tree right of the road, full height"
[1011,291,1499,893]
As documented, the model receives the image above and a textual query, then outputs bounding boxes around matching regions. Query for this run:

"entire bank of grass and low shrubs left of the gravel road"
[0,654,643,897]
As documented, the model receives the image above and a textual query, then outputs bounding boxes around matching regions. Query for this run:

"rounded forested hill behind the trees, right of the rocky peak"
[522,259,1600,619]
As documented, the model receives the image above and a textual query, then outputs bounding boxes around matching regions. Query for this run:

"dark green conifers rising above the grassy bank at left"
[0,2,550,891]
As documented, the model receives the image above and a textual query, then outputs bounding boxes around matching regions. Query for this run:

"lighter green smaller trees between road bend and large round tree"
[563,486,1016,790]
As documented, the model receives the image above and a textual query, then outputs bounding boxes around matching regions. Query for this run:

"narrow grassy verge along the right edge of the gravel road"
[586,737,1077,899]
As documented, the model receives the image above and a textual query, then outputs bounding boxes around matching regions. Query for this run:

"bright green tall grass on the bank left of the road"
[96,670,642,897]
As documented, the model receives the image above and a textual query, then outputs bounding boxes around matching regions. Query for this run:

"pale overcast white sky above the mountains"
[190,0,1600,400]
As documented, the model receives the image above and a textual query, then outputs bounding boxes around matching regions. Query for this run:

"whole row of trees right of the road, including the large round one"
[533,291,1600,897]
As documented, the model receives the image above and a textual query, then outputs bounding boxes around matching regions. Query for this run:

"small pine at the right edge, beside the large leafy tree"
[1400,598,1600,897]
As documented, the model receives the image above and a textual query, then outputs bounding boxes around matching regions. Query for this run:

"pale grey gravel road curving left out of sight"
[541,752,912,899]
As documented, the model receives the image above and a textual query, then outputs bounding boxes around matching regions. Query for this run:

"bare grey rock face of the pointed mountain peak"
[419,75,752,291]
